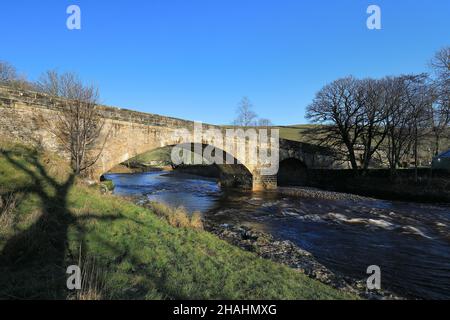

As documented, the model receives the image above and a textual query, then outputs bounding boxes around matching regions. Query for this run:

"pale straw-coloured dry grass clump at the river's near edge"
[148,202,203,230]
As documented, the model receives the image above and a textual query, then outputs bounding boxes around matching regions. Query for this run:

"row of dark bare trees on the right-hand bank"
[306,47,450,178]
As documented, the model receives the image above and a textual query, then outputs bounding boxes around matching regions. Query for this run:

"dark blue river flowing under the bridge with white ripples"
[106,172,450,299]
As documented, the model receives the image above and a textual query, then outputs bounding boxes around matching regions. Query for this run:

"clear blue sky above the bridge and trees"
[0,0,450,124]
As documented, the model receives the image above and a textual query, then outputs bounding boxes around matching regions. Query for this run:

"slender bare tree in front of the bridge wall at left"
[37,71,106,175]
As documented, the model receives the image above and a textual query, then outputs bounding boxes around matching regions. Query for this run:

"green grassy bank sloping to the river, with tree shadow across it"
[0,143,355,299]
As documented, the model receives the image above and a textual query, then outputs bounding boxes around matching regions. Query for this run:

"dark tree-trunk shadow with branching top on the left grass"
[0,151,121,299]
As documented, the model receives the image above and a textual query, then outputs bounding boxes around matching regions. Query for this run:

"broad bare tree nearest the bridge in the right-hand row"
[307,77,387,171]
